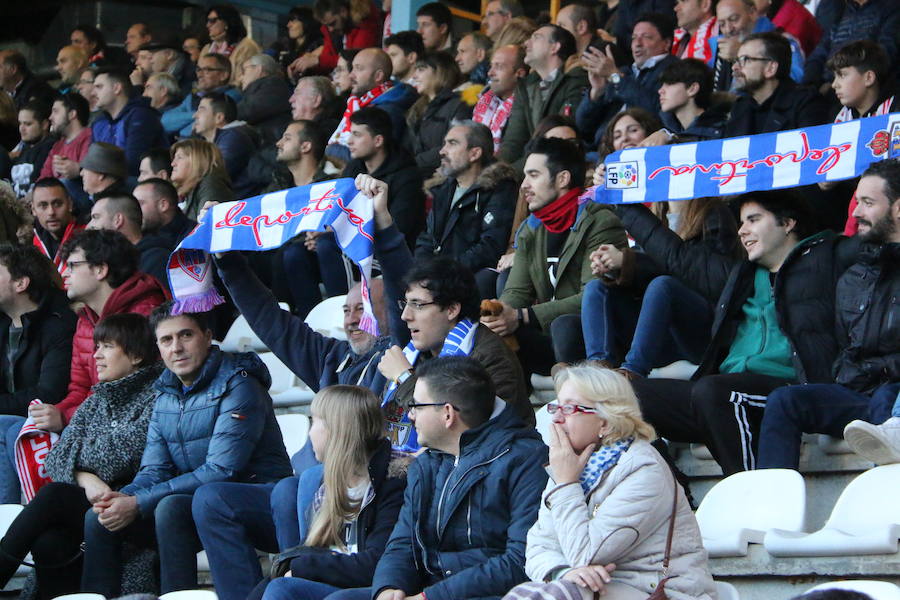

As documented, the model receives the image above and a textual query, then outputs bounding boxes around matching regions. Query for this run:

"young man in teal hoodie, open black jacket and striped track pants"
[626,190,858,475]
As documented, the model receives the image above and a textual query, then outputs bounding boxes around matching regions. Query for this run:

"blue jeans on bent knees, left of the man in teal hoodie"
[581,275,713,377]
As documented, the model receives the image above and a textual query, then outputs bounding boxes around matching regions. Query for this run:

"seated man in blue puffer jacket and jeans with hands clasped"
[82,303,291,598]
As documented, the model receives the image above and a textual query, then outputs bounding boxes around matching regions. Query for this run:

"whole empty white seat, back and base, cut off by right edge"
[763,464,900,556]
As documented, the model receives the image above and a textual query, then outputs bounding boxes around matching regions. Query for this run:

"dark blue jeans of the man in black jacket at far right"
[759,383,900,469]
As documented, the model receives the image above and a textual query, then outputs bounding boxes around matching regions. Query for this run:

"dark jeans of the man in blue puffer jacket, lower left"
[81,494,203,598]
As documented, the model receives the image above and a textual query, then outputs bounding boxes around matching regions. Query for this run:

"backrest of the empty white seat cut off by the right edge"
[825,464,900,535]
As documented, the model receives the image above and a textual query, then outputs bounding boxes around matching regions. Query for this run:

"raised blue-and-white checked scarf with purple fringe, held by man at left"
[169,178,378,335]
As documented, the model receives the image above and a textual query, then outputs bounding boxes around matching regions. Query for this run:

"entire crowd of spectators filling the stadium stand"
[0,0,900,600]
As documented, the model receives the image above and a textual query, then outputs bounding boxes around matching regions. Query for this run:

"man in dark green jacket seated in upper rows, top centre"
[499,24,588,169]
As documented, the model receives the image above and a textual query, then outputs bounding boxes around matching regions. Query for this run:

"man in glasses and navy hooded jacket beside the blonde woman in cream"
[334,356,547,600]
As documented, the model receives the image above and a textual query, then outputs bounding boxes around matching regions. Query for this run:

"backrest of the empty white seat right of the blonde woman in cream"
[697,469,806,539]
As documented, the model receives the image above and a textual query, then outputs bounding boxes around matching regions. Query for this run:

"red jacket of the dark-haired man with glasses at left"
[56,271,169,424]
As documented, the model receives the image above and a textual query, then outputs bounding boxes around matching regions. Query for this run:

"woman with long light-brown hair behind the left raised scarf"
[169,138,234,219]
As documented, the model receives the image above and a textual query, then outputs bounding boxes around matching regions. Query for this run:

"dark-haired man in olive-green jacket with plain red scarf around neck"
[481,138,627,375]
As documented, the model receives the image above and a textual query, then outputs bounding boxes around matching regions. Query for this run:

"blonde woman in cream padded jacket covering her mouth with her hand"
[506,365,715,600]
